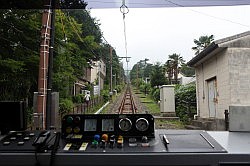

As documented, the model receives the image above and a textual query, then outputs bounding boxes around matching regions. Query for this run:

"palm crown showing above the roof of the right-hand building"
[192,35,214,55]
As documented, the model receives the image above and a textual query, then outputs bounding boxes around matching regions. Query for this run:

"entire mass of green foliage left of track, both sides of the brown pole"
[0,9,124,114]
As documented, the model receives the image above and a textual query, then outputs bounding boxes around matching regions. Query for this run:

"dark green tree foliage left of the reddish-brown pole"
[0,10,41,100]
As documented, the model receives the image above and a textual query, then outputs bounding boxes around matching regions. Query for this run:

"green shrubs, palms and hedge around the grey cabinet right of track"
[130,53,196,122]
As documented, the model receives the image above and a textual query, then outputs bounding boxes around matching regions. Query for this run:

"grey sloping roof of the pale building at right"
[187,31,250,67]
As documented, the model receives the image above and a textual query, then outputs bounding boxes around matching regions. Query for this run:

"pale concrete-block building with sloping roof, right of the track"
[188,31,250,130]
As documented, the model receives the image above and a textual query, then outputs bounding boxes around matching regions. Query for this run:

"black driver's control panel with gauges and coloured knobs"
[62,114,155,152]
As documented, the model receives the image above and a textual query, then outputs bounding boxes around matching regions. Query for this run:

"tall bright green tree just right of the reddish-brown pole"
[53,10,106,98]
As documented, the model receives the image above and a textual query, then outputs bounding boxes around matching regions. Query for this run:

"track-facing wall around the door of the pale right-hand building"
[196,50,230,119]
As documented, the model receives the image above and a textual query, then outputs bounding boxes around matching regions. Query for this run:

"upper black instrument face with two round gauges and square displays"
[62,114,155,139]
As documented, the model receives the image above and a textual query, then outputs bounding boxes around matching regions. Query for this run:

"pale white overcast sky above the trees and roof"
[90,6,250,70]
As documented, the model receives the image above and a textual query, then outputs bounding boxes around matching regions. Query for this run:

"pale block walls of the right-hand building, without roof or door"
[196,48,250,119]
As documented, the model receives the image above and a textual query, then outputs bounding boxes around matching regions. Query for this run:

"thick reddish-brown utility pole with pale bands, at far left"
[34,1,52,129]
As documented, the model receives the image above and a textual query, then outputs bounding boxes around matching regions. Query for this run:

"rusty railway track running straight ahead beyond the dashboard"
[116,86,137,114]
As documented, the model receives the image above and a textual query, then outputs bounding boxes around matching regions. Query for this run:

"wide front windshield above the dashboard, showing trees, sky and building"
[0,1,250,130]
